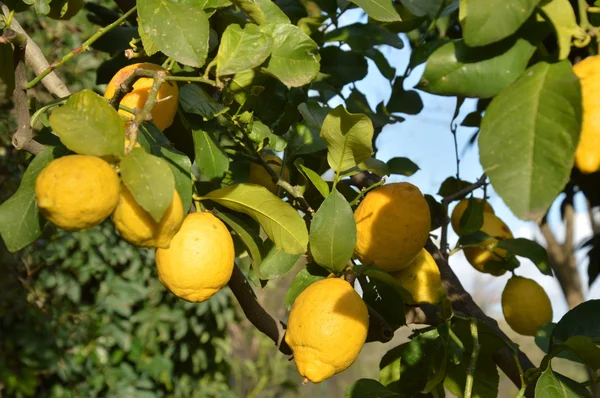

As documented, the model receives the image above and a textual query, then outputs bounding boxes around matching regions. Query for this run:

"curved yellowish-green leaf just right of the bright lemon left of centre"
[203,184,308,254]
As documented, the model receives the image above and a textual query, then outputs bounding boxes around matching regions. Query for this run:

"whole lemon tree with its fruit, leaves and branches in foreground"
[0,0,600,398]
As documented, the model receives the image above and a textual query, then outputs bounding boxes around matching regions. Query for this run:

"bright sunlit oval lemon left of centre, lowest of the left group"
[156,212,234,302]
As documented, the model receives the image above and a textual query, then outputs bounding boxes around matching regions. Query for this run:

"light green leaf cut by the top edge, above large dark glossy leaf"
[459,0,540,47]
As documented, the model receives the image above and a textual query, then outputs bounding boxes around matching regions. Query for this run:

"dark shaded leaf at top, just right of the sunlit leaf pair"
[323,23,404,54]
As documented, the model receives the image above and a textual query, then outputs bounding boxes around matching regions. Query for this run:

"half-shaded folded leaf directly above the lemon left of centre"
[138,123,192,211]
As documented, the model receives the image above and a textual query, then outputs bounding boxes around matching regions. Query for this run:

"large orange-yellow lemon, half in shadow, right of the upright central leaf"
[354,182,431,272]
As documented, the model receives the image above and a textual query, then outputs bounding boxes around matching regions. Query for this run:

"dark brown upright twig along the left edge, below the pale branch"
[2,29,46,155]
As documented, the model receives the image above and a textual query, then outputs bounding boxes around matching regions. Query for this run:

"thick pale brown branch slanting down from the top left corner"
[0,1,71,98]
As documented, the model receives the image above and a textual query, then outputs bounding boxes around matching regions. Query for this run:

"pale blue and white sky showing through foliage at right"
[330,10,600,321]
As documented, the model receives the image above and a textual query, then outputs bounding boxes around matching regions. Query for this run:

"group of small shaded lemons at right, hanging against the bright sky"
[451,199,552,336]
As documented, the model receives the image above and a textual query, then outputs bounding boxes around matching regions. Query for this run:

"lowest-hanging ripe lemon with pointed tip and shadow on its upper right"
[285,278,369,383]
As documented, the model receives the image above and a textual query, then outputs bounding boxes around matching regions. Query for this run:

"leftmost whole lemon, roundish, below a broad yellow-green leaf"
[35,155,120,231]
